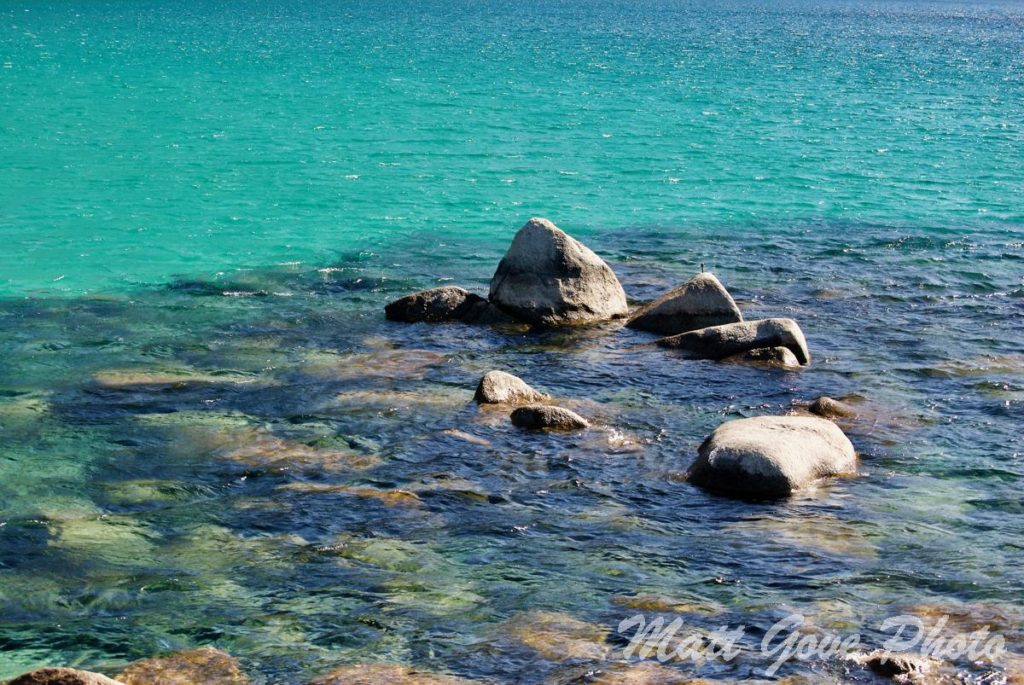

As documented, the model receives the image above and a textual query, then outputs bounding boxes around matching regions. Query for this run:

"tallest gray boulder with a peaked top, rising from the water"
[490,219,628,326]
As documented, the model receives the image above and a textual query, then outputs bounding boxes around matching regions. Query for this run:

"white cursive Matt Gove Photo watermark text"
[617,613,1006,676]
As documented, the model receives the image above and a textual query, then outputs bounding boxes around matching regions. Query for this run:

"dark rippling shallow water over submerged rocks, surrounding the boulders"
[0,224,1024,682]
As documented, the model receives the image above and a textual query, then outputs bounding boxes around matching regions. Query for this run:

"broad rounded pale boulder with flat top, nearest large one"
[688,416,857,499]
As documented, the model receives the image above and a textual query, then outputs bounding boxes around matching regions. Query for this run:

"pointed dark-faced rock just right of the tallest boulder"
[626,272,743,336]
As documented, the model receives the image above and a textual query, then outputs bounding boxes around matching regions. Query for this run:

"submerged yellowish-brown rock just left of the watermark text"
[503,610,610,661]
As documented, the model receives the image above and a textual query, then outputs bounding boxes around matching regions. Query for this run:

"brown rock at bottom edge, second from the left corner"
[118,647,251,685]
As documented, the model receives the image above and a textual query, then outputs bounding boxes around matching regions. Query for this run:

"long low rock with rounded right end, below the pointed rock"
[657,318,811,365]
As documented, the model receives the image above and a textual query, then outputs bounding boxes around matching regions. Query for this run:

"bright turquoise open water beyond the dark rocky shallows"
[0,0,1024,295]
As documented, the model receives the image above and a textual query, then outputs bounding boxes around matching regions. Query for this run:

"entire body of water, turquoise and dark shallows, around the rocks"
[0,2,1024,683]
